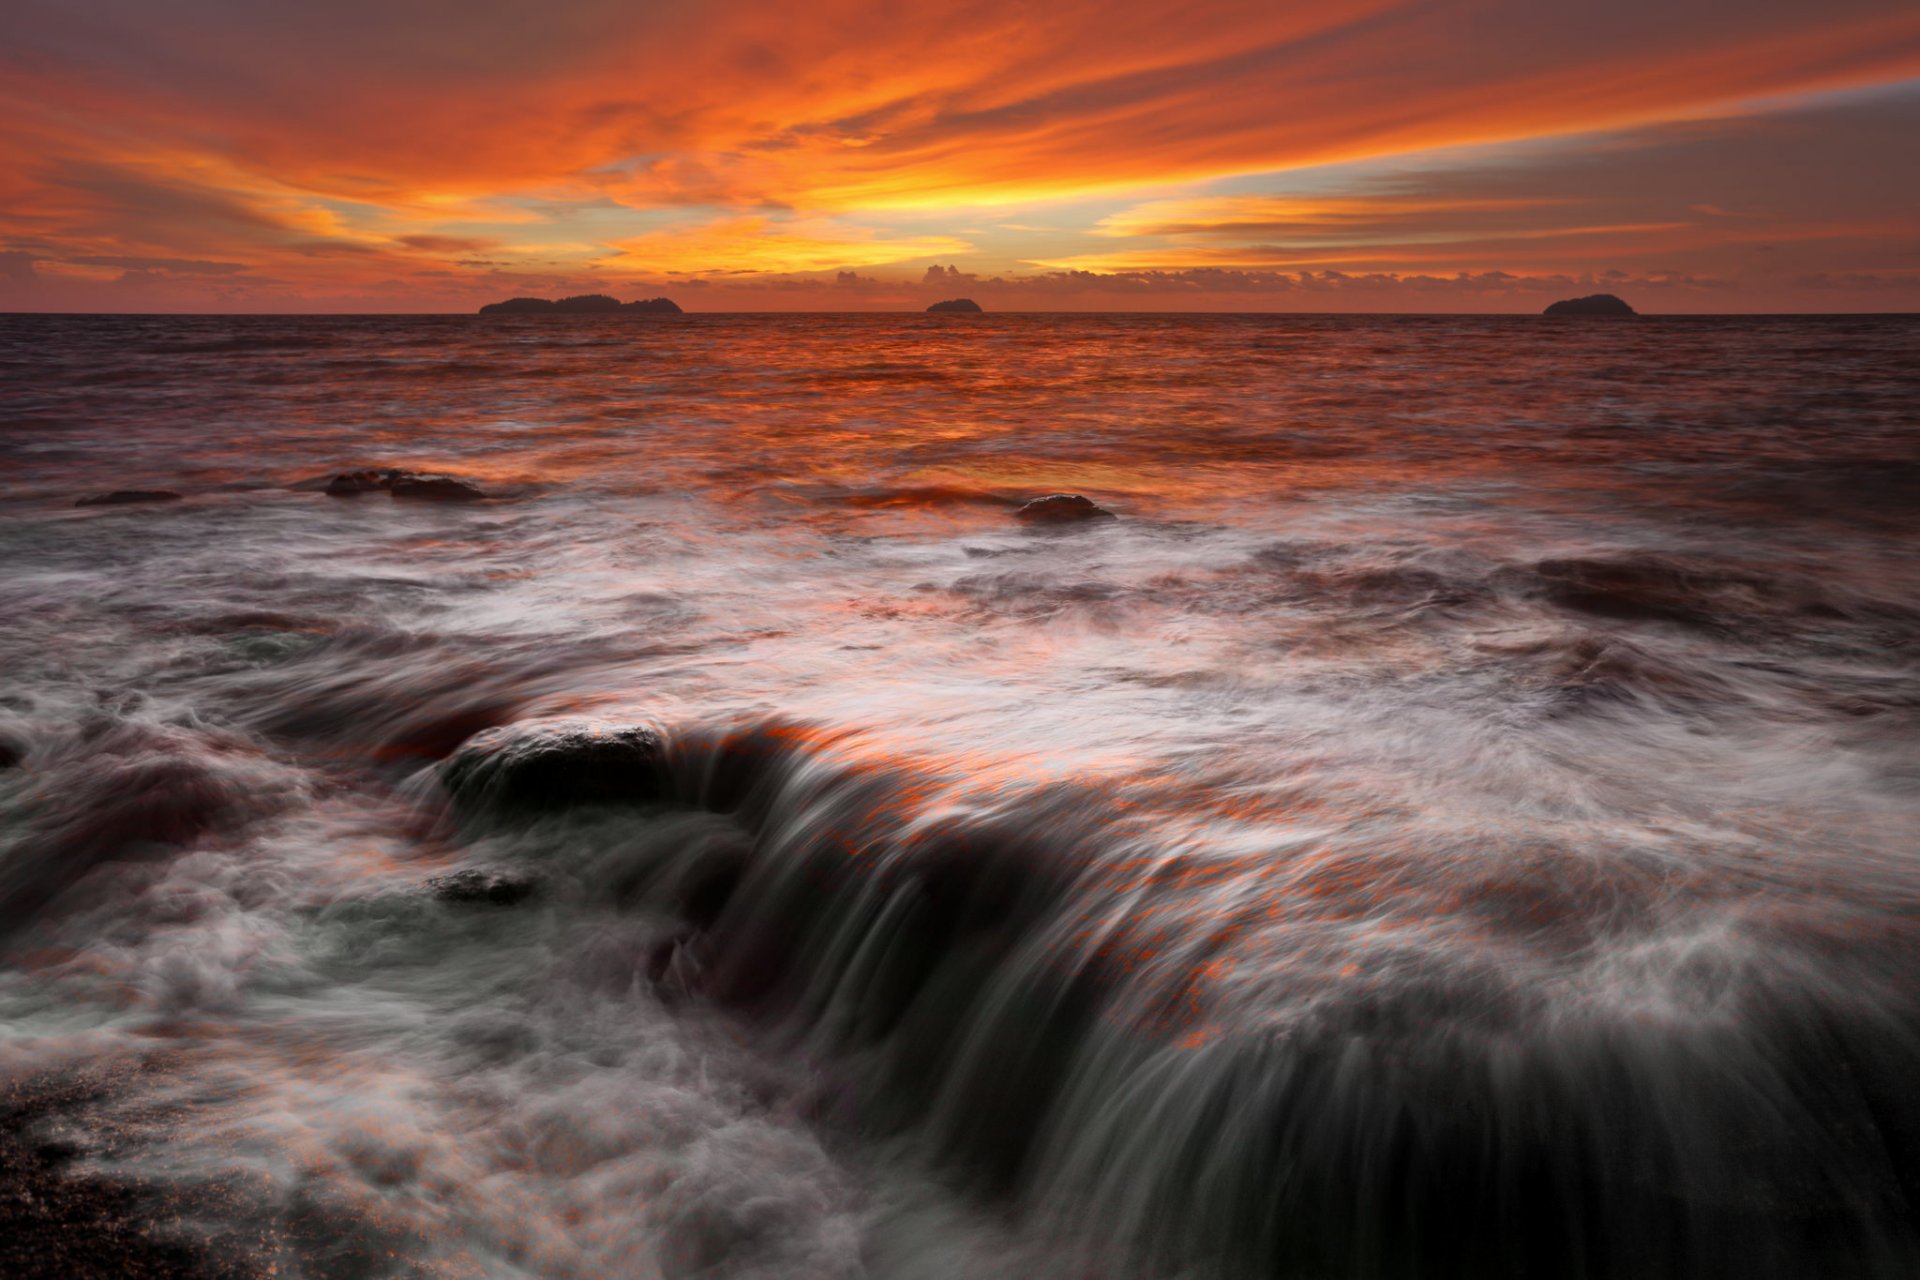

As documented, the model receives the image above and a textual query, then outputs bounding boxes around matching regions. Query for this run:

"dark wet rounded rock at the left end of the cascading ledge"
[440,720,668,812]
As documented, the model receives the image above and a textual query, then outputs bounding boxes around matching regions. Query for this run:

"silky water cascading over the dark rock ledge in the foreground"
[416,722,1920,1276]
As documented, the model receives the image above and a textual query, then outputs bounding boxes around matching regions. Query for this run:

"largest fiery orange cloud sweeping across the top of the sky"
[15,0,1920,211]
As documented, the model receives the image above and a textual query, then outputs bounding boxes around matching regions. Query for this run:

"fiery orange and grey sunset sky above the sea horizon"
[0,0,1920,313]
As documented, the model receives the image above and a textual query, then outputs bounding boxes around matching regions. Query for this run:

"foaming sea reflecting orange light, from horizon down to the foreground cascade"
[0,315,1920,1280]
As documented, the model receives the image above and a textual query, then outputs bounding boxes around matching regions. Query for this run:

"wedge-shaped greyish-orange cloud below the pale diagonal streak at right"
[1035,92,1920,288]
